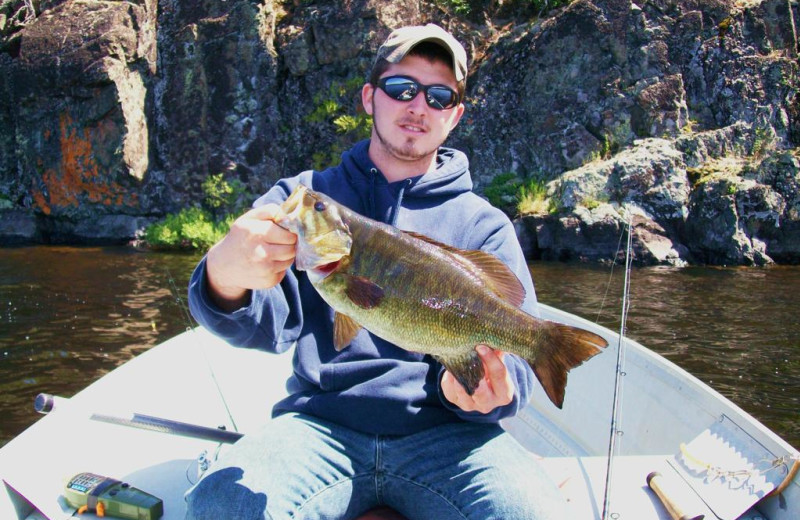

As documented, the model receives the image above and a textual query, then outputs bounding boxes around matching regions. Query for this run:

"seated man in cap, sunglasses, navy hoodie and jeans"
[187,24,563,520]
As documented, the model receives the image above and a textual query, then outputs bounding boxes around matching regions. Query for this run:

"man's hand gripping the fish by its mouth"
[206,204,297,311]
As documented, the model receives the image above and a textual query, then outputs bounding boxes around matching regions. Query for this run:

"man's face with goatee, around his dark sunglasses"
[361,56,464,171]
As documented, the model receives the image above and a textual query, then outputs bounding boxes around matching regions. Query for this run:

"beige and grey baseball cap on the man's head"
[377,23,467,81]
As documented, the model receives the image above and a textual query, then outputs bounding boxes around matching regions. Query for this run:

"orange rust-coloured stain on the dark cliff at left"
[35,112,138,214]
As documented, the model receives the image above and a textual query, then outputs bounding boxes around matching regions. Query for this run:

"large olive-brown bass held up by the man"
[278,185,608,408]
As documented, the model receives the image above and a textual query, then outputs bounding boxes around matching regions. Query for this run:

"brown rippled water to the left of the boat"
[0,247,198,445]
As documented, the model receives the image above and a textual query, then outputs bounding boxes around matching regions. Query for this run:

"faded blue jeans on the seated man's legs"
[186,414,566,520]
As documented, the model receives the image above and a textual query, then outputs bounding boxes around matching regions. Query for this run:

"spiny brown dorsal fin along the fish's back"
[404,231,525,307]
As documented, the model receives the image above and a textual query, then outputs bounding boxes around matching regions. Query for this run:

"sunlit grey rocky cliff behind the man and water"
[0,0,800,264]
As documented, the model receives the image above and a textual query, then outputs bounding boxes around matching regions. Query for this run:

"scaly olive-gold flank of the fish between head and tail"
[340,219,527,357]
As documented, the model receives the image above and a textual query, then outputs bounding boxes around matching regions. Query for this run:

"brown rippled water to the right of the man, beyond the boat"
[531,263,800,447]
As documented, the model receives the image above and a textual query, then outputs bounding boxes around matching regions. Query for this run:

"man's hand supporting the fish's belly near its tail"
[441,345,514,414]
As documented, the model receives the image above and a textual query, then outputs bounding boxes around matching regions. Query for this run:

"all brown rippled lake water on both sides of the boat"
[0,247,800,447]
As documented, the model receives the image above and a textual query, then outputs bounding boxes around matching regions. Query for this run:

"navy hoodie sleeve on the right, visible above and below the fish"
[438,203,539,423]
